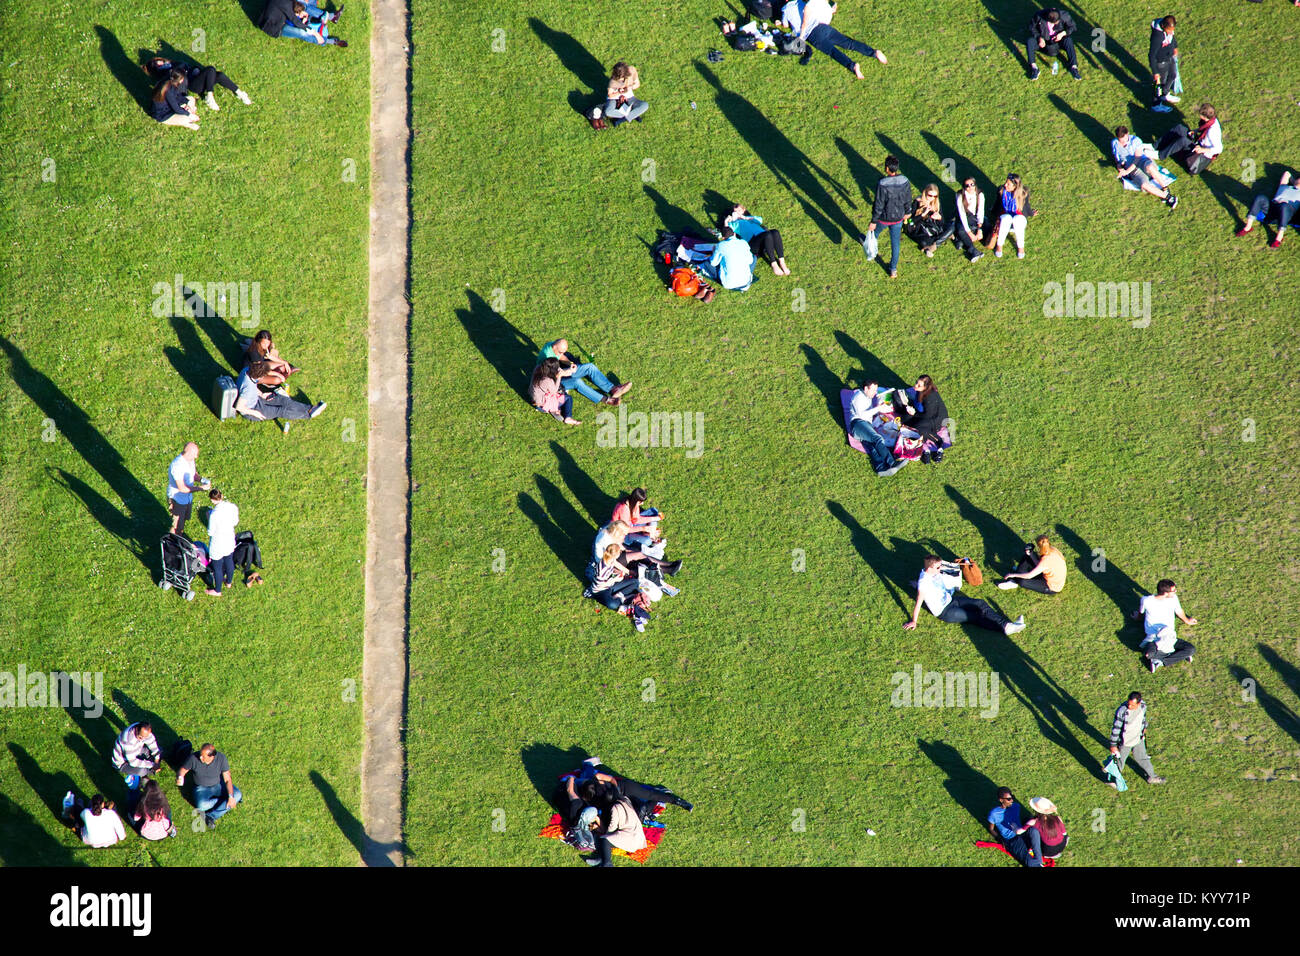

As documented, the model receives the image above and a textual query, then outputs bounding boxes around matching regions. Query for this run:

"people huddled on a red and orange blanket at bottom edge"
[558,757,693,866]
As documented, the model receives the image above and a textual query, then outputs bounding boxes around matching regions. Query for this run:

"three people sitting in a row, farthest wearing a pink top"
[582,488,681,631]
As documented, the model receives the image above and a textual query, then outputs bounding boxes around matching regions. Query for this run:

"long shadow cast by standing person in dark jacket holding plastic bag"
[696,62,861,243]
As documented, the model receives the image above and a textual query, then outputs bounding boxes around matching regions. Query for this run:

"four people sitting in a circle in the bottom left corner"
[62,721,243,848]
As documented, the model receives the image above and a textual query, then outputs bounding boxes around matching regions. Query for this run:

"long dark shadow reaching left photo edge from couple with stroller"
[0,336,168,554]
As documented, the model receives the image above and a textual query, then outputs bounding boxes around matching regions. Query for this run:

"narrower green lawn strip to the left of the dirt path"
[0,0,369,865]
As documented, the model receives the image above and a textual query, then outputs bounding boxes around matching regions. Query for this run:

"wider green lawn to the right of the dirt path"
[407,0,1300,865]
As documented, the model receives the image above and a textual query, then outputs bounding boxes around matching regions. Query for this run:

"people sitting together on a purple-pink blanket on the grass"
[848,375,953,477]
